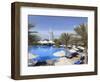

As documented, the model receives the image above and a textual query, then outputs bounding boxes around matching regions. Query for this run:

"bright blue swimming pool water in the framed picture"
[28,46,70,62]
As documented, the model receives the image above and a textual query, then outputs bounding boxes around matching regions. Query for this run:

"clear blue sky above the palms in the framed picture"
[28,15,88,39]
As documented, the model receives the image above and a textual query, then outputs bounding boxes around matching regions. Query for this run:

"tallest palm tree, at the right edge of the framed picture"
[74,24,88,63]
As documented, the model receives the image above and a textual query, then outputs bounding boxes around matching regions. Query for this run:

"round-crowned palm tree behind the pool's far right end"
[60,33,71,47]
